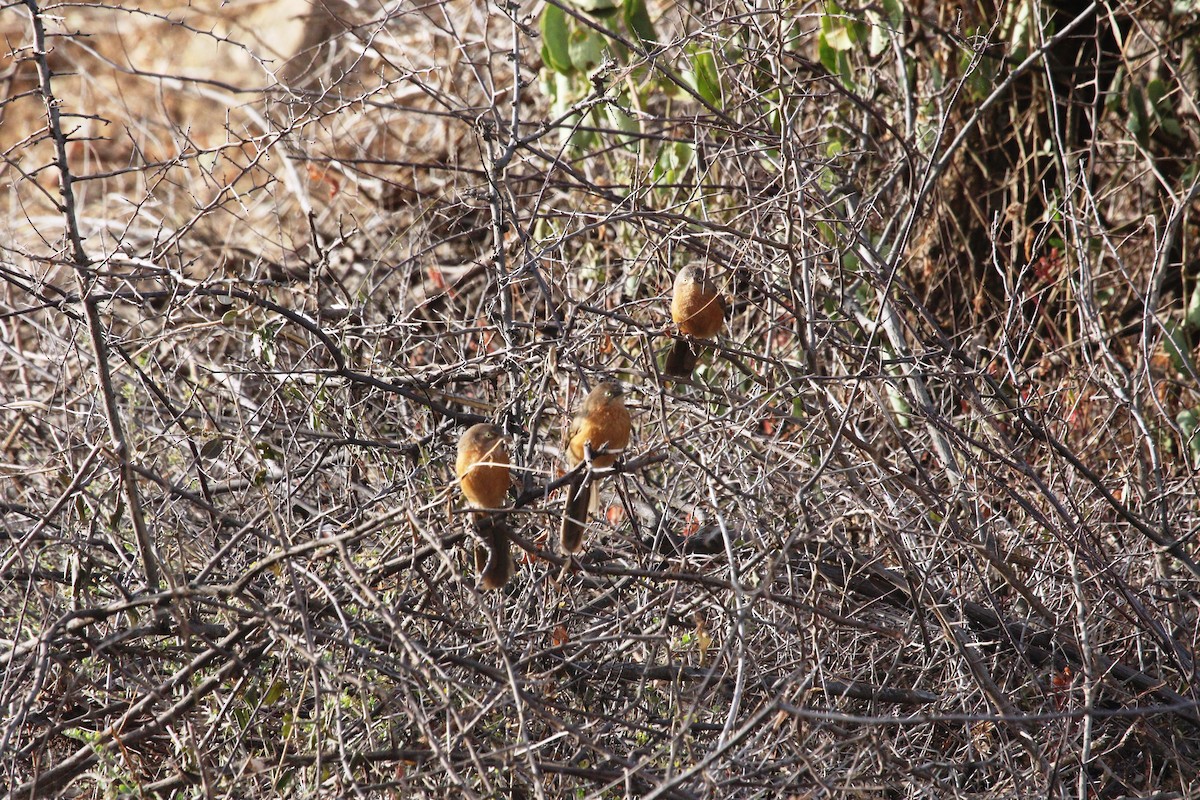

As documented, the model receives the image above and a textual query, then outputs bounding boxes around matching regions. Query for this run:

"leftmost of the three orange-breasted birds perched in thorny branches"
[454,422,512,589]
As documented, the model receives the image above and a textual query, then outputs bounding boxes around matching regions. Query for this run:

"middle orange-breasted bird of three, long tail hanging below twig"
[560,383,630,553]
